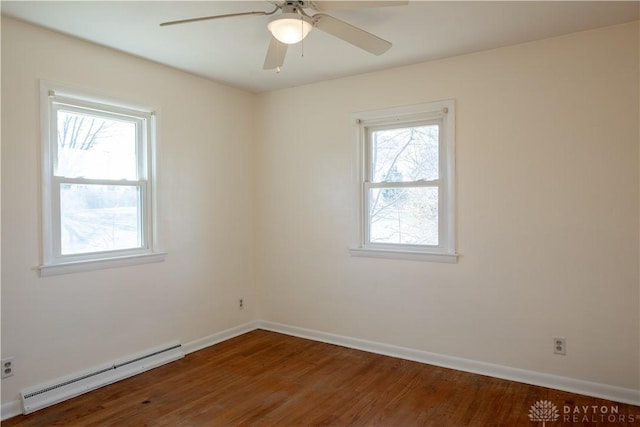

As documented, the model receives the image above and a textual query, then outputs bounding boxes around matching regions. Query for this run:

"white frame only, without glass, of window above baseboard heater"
[39,80,166,277]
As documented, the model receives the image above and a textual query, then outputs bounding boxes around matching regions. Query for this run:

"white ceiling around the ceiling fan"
[1,0,639,92]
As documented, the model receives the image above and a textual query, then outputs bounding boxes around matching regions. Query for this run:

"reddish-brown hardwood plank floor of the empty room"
[2,330,640,427]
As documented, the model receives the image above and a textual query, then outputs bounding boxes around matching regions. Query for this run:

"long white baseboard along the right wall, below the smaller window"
[259,321,640,405]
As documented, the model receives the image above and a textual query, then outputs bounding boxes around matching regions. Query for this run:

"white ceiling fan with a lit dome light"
[160,1,409,71]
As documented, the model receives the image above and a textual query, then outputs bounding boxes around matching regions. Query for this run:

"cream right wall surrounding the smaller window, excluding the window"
[256,23,639,389]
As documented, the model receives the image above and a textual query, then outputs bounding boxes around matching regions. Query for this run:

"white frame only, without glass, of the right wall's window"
[349,99,458,263]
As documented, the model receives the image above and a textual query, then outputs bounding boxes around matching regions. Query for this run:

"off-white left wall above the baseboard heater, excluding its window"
[2,17,255,403]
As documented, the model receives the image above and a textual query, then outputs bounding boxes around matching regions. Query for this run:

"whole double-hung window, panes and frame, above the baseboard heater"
[40,82,164,275]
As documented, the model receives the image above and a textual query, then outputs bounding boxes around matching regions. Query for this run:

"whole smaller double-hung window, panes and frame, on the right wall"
[351,100,457,262]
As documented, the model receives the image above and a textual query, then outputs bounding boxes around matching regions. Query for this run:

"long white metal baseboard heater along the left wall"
[20,343,184,414]
